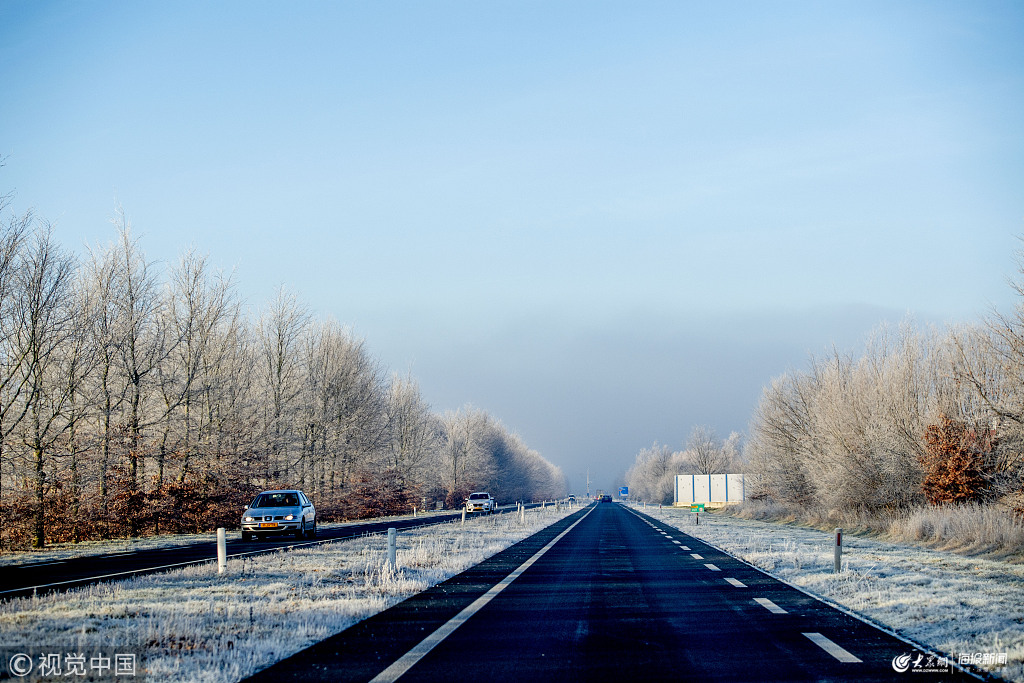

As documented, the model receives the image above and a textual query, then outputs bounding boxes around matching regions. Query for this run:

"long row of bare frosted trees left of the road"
[0,201,565,547]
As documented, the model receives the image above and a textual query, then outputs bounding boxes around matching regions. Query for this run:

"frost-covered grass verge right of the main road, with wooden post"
[641,507,1024,682]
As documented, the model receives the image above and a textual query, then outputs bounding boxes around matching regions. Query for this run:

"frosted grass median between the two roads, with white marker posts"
[0,506,571,682]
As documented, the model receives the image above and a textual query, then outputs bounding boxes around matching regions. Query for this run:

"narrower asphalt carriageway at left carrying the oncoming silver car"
[0,505,534,599]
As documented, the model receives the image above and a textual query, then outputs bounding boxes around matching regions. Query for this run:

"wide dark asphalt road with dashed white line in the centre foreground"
[243,503,977,683]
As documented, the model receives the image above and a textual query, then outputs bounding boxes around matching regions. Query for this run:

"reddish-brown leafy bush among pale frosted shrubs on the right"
[919,416,992,505]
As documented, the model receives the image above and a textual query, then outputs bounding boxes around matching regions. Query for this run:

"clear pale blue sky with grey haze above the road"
[0,0,1024,486]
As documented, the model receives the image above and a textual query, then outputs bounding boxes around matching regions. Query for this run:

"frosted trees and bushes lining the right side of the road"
[627,265,1024,515]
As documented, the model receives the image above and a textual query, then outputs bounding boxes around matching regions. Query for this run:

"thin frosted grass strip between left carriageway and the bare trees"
[0,510,452,566]
